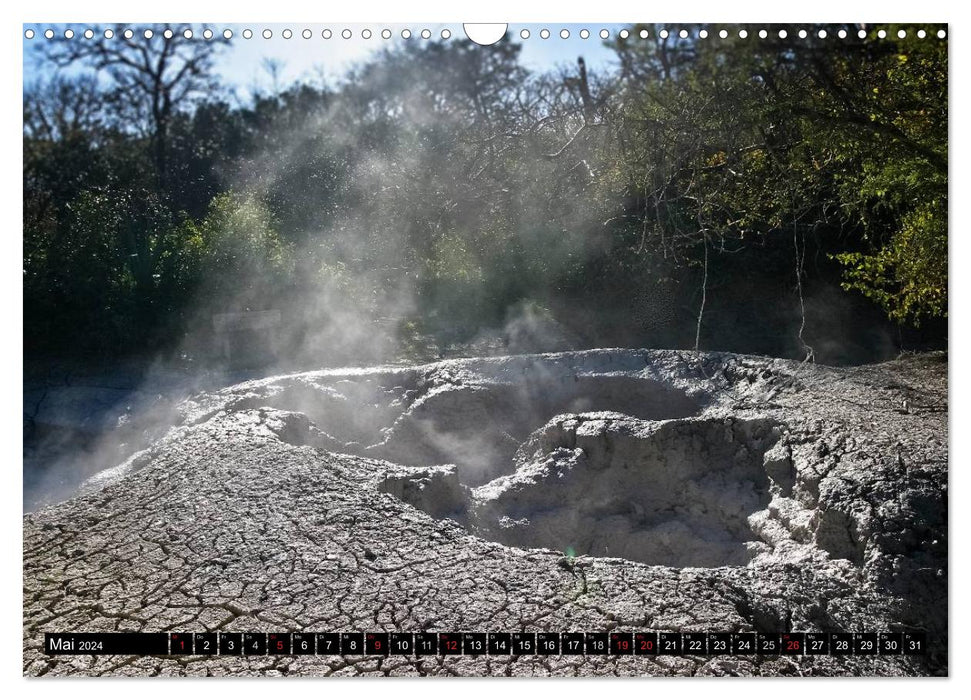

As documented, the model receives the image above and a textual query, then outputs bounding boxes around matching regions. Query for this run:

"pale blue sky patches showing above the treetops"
[23,23,620,96]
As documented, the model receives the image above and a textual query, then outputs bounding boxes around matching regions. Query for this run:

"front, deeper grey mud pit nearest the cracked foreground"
[468,414,778,567]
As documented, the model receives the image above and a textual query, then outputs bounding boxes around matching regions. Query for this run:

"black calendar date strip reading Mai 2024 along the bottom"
[44,632,927,656]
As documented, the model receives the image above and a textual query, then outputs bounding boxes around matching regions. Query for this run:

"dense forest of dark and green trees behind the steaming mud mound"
[23,25,948,366]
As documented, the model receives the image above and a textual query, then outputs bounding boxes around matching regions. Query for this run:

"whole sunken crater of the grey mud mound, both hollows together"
[258,374,782,567]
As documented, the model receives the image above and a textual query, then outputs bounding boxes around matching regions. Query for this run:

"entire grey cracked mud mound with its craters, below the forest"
[23,350,947,676]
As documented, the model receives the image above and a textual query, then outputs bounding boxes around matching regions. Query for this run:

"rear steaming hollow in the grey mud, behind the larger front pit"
[254,373,707,486]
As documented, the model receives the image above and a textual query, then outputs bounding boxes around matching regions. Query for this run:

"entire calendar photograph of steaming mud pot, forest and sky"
[23,24,948,677]
